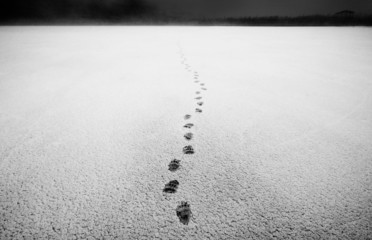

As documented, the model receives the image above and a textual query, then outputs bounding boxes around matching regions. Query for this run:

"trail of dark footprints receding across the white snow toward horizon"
[163,48,207,225]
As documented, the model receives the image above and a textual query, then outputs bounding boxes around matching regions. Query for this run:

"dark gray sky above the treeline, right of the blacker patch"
[147,0,372,17]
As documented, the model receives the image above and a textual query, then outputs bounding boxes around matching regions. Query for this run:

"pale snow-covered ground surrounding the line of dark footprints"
[0,26,372,239]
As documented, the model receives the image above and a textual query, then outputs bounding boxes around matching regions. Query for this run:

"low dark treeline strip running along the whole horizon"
[0,14,372,26]
